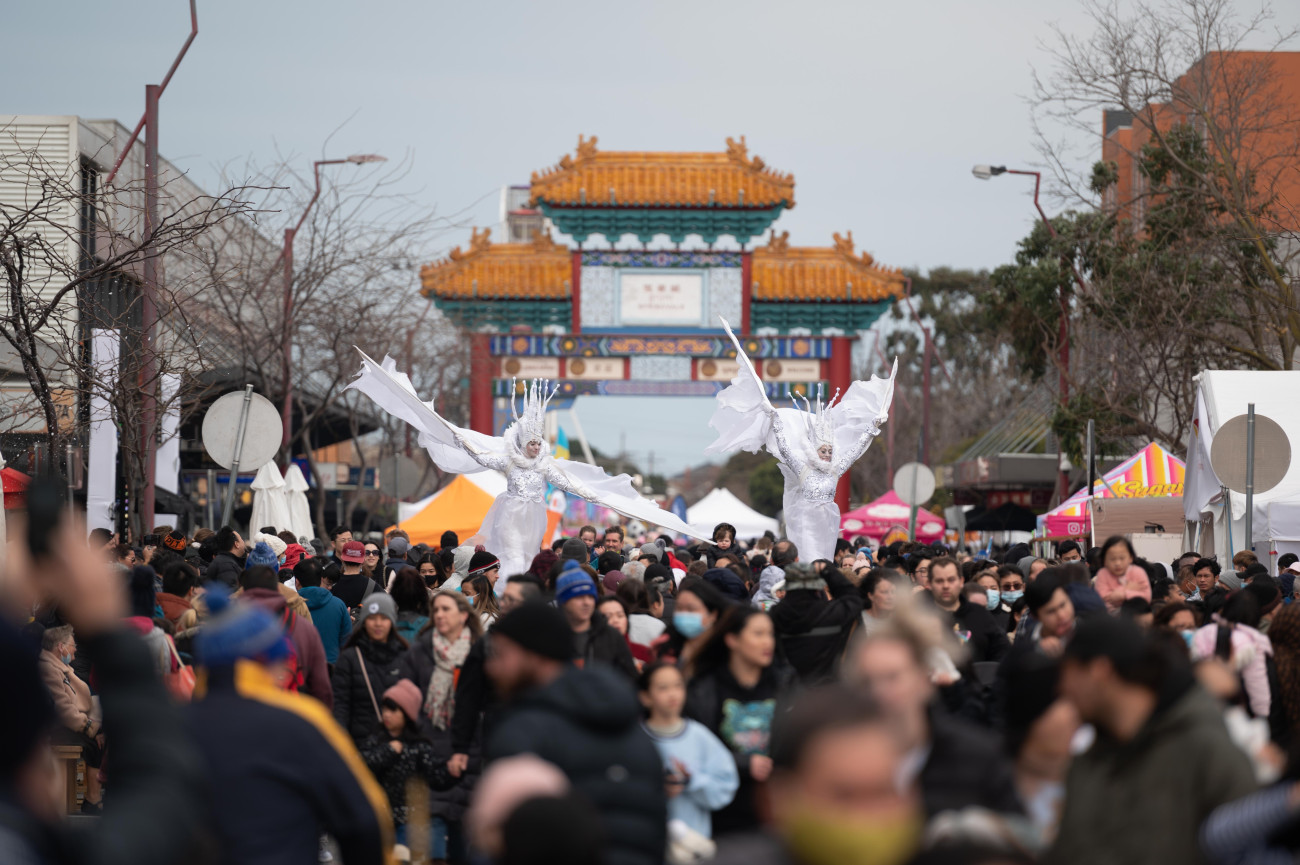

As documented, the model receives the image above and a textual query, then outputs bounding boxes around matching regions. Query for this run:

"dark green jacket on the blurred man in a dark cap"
[1043,684,1256,865]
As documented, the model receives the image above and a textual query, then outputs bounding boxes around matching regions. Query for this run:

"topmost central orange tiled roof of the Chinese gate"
[532,135,794,208]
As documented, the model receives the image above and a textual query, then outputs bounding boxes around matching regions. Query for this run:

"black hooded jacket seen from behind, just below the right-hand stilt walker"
[770,567,862,685]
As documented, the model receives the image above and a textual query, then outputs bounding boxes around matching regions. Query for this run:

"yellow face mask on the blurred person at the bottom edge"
[784,808,922,865]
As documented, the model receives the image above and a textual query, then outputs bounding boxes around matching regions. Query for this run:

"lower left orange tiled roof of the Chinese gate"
[420,229,573,300]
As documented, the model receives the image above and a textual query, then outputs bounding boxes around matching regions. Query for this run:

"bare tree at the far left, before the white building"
[0,129,263,531]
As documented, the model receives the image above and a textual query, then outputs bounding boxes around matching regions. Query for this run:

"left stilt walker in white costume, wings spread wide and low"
[348,353,703,594]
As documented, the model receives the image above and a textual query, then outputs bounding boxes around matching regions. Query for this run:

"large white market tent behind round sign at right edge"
[1183,369,1300,559]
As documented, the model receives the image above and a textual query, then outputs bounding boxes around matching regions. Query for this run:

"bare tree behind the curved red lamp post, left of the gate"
[192,153,464,535]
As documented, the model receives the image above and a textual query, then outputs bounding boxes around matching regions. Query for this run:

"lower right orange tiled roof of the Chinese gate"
[753,230,904,302]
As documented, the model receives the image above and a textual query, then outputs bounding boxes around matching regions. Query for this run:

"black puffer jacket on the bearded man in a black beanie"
[488,665,668,865]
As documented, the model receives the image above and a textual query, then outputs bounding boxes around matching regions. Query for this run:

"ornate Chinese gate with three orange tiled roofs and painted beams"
[420,138,904,509]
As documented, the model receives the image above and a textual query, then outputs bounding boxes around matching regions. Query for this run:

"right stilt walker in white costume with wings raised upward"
[705,320,898,562]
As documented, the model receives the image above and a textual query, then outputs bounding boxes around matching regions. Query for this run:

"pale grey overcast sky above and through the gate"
[0,0,1300,470]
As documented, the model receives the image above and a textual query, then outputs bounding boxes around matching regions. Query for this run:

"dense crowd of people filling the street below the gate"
[0,512,1300,865]
